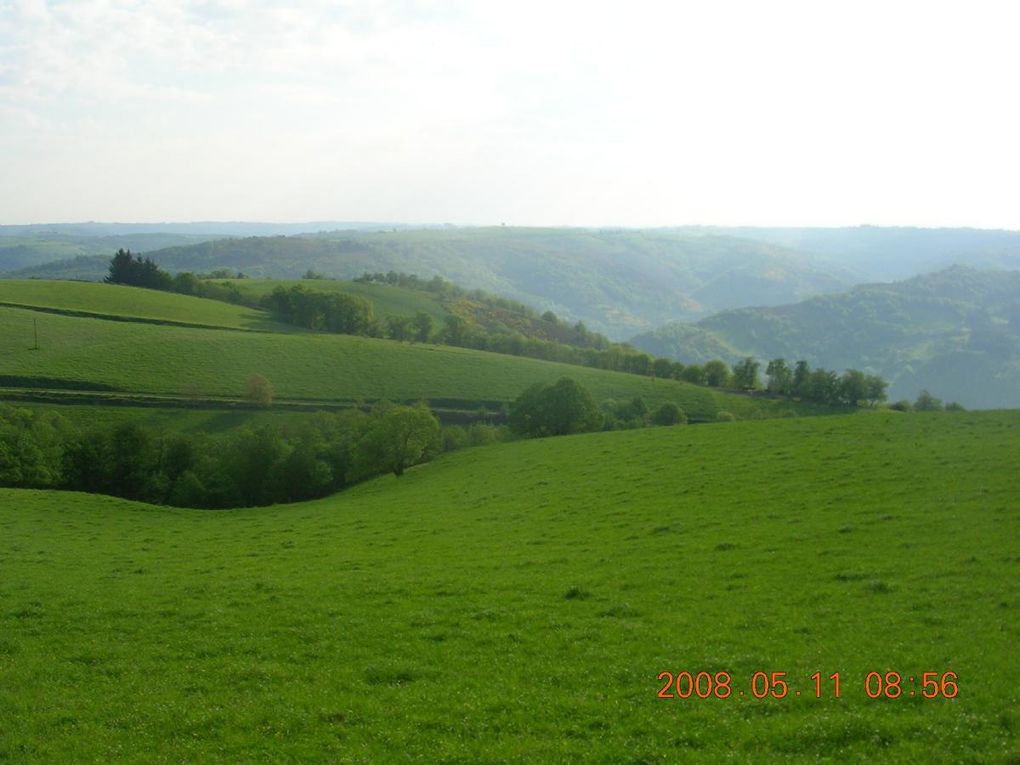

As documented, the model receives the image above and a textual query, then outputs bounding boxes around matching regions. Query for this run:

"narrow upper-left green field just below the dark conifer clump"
[0,279,297,333]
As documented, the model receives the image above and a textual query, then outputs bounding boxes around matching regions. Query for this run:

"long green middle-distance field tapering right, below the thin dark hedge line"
[0,308,803,418]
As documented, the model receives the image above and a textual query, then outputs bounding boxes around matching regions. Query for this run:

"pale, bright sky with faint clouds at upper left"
[0,0,1020,230]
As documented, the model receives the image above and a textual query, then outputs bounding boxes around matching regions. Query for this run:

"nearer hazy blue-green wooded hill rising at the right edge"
[631,266,1020,408]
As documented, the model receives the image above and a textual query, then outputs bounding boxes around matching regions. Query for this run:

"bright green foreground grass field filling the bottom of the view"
[0,411,1020,763]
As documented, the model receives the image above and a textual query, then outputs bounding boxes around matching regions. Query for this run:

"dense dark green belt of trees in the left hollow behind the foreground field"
[0,402,485,508]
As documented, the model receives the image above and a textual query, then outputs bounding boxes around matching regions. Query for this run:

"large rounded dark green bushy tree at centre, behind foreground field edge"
[509,377,599,438]
